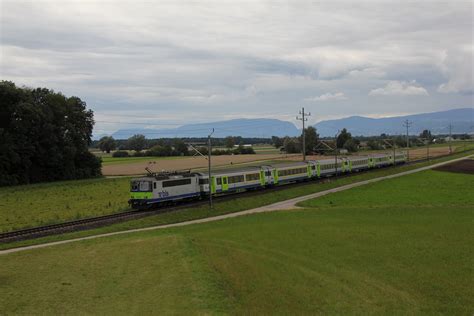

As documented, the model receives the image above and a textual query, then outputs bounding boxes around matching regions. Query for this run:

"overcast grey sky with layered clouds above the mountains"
[0,0,474,134]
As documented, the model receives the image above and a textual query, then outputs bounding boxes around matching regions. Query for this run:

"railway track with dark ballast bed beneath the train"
[0,151,472,243]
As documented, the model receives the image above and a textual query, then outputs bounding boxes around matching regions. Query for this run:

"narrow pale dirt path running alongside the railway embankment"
[0,157,467,255]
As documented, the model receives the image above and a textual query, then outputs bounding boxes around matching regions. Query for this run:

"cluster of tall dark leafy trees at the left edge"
[0,81,101,185]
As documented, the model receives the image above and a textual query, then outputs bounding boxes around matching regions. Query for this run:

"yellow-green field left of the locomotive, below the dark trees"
[0,178,130,232]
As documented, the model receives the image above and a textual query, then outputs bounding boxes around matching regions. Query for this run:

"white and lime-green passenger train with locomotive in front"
[129,152,407,209]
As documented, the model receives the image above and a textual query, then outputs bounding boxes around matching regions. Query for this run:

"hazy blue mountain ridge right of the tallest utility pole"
[314,108,474,136]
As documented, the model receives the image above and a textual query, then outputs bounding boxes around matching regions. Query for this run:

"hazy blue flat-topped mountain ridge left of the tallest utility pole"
[112,119,301,139]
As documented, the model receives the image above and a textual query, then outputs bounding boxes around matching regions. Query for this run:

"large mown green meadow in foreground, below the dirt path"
[0,171,474,314]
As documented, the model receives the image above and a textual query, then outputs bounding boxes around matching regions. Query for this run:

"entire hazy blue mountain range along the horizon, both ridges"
[94,108,474,139]
